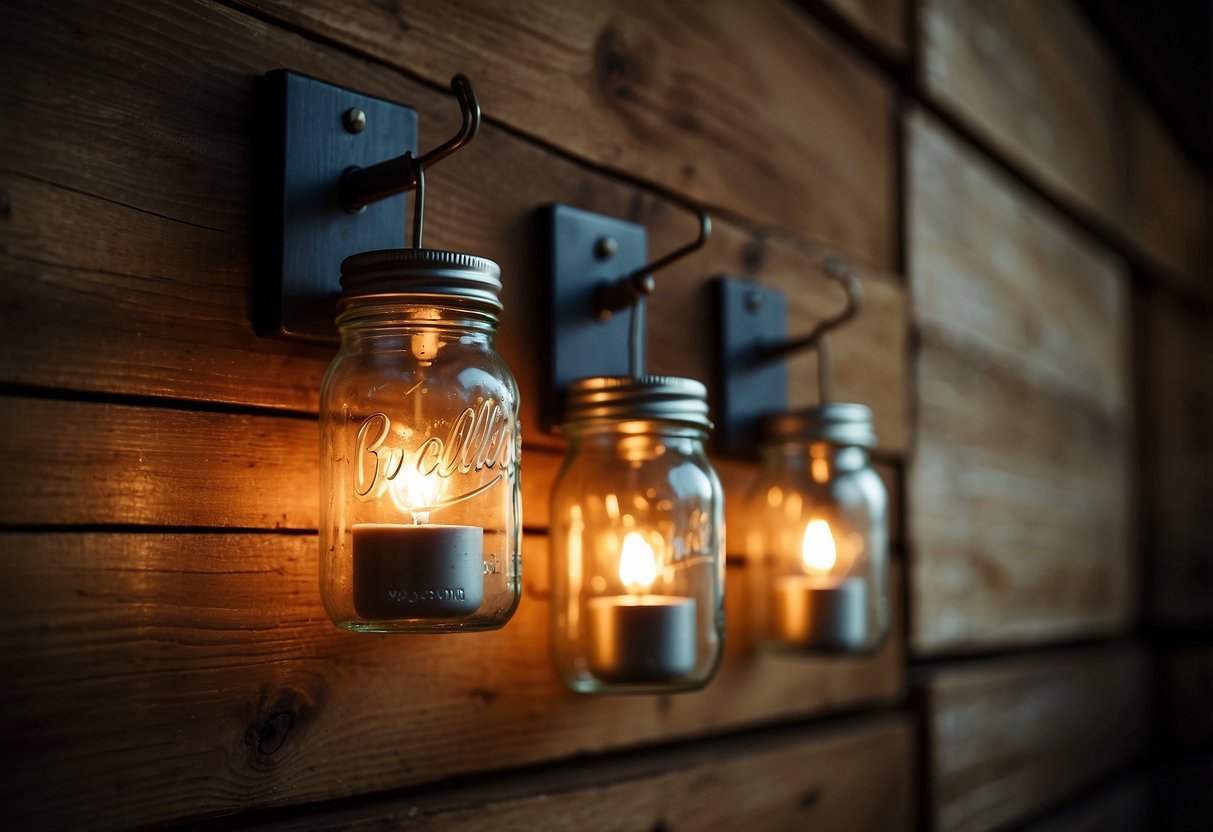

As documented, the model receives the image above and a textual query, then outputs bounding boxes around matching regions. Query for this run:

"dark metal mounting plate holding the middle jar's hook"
[540,205,648,431]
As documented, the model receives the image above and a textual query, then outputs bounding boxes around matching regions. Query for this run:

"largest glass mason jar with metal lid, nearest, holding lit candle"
[320,249,522,633]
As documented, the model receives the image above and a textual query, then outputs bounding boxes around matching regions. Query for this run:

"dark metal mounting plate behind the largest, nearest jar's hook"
[252,69,417,341]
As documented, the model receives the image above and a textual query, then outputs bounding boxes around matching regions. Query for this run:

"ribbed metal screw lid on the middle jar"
[564,376,712,432]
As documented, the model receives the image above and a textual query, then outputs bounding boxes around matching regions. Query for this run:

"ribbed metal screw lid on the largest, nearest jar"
[341,249,501,314]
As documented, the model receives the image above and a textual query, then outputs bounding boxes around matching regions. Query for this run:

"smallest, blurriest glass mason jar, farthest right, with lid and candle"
[746,403,889,654]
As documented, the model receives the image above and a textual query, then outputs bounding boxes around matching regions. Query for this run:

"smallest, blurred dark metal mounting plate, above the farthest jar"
[716,278,788,454]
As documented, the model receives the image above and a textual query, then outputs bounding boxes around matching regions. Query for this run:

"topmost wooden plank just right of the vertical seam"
[918,0,1127,228]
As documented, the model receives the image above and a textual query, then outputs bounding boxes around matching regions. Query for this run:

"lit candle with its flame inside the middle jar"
[587,531,699,684]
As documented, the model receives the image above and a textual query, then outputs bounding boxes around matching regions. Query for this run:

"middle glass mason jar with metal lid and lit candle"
[551,376,724,693]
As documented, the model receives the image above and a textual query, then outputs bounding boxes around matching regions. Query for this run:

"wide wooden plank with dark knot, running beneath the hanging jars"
[0,534,904,828]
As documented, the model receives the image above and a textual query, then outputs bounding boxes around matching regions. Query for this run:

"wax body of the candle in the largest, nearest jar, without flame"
[353,523,484,621]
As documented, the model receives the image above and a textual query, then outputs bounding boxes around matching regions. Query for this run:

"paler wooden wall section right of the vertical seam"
[905,0,1213,830]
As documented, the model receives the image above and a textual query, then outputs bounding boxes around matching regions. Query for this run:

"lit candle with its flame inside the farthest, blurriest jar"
[774,519,867,651]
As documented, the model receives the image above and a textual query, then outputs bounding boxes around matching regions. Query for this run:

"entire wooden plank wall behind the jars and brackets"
[0,0,1213,831]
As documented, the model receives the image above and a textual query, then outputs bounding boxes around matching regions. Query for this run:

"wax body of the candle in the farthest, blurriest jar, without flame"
[775,575,867,651]
